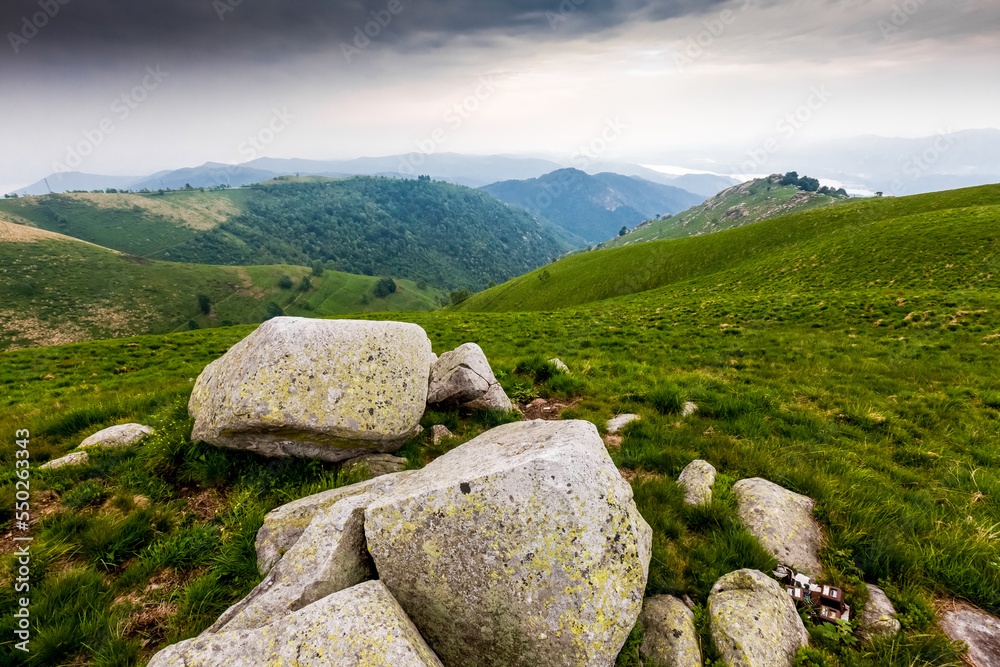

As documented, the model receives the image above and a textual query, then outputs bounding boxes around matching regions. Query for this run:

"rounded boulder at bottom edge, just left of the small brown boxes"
[708,570,809,667]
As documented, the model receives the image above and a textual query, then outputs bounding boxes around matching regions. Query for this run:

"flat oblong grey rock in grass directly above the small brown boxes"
[733,478,823,577]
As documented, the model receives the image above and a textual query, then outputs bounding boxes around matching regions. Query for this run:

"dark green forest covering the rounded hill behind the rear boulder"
[157,176,570,290]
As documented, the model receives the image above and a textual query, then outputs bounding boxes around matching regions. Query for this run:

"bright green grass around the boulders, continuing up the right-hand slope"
[0,187,1000,667]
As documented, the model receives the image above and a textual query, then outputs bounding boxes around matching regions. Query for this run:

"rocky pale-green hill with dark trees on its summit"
[597,175,847,249]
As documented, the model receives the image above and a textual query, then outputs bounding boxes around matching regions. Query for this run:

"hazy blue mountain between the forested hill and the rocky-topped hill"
[482,169,704,244]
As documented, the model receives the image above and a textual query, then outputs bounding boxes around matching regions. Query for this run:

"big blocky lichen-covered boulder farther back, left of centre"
[188,317,431,461]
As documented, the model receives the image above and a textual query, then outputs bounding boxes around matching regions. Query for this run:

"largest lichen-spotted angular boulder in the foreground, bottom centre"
[365,421,651,667]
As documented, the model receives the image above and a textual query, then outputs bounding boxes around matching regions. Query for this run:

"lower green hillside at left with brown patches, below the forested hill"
[0,231,439,349]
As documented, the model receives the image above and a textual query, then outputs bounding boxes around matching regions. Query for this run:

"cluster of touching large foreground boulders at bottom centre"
[150,421,652,667]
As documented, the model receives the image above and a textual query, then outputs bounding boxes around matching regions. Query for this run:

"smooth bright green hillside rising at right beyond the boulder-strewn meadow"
[460,185,1000,311]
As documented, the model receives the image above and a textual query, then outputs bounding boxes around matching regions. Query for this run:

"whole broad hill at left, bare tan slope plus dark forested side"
[0,177,571,289]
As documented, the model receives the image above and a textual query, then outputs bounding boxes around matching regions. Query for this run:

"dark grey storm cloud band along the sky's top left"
[0,0,725,64]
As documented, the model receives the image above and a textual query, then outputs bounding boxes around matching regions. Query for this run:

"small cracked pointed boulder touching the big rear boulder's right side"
[427,343,513,411]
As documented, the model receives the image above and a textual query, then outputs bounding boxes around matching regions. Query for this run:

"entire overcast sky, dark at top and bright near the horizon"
[0,0,1000,191]
